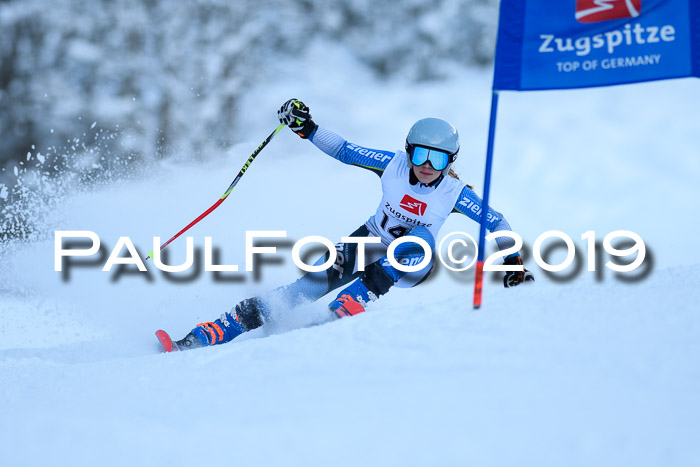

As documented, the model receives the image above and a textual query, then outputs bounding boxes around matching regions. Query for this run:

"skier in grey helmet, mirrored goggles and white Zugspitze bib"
[175,99,534,350]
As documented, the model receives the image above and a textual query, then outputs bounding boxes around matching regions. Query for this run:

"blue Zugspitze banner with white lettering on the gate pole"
[493,0,700,90]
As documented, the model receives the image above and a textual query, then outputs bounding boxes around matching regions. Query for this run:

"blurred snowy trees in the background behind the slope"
[0,0,497,239]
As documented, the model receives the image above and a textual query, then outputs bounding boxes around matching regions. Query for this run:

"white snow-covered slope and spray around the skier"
[0,50,700,466]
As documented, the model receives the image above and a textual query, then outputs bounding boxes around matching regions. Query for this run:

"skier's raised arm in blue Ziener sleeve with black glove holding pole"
[277,99,395,177]
